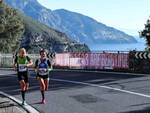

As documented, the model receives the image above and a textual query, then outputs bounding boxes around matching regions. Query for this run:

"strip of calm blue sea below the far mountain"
[89,42,146,51]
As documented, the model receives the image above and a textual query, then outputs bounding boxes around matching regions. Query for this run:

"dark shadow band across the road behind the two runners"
[0,71,146,95]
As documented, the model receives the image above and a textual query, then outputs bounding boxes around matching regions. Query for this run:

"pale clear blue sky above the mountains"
[37,0,150,36]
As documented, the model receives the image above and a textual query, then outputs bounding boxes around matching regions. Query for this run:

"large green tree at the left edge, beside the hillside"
[0,0,24,53]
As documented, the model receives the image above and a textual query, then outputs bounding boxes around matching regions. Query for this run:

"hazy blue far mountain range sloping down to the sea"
[6,0,137,45]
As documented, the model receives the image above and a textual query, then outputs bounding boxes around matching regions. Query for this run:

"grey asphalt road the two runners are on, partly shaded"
[0,70,150,113]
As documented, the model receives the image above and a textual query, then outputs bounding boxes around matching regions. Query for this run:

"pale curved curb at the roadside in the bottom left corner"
[0,91,40,113]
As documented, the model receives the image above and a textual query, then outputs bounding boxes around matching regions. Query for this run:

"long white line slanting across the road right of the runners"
[51,78,150,98]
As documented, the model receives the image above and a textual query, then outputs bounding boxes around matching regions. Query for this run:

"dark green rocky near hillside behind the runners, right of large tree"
[18,12,90,53]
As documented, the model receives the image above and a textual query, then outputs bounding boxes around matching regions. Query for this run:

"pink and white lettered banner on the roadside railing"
[55,53,129,69]
